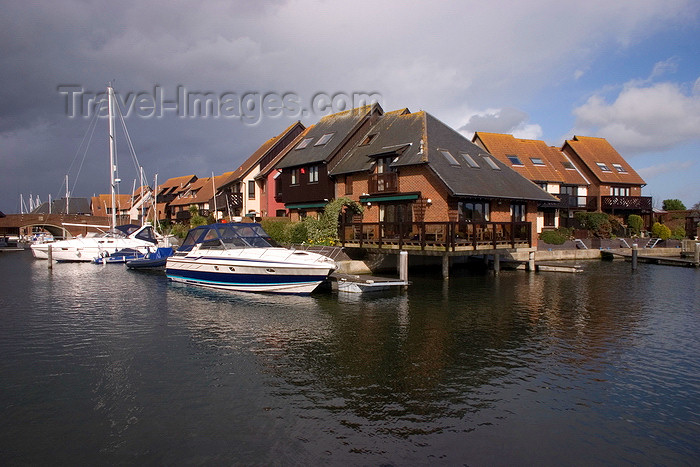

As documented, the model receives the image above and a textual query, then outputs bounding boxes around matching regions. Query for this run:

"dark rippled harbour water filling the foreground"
[0,253,700,466]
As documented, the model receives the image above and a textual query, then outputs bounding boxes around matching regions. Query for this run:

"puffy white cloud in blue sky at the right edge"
[573,82,700,153]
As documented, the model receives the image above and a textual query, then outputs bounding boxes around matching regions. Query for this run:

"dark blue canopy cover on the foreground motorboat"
[177,223,278,251]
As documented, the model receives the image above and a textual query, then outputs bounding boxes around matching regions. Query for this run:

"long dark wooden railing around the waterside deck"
[338,222,532,251]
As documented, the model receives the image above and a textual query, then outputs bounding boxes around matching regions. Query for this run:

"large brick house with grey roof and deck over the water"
[329,109,558,248]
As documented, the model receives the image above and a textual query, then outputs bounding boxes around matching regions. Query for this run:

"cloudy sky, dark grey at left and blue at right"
[0,0,700,213]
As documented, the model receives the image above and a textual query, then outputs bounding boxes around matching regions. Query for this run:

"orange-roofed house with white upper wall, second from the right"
[472,131,590,232]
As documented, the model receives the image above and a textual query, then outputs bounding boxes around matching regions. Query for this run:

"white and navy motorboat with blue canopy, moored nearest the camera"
[165,223,336,294]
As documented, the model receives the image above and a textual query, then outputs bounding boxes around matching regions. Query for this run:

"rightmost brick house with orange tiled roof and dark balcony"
[562,136,652,228]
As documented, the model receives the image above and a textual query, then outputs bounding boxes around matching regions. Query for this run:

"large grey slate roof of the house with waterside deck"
[330,109,558,202]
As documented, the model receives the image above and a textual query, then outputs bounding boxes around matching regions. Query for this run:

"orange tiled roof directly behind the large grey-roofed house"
[472,131,588,185]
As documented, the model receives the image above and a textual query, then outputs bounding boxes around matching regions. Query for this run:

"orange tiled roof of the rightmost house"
[562,136,646,185]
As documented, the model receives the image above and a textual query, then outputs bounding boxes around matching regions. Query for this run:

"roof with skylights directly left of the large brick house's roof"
[277,104,384,169]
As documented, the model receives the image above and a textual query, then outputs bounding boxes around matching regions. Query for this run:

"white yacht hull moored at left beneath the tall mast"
[31,224,158,262]
